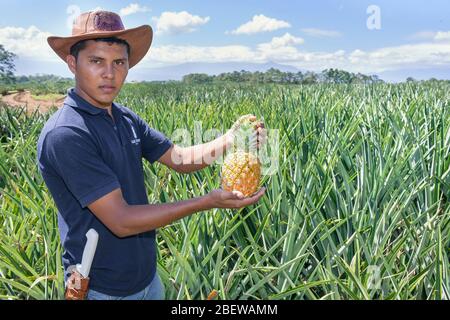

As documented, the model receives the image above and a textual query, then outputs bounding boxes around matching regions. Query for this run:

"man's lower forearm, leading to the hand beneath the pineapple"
[119,196,212,237]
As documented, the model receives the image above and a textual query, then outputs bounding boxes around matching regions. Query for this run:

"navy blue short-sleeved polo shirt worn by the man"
[37,89,173,296]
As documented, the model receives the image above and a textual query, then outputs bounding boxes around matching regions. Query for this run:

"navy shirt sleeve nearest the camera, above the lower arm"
[42,127,120,208]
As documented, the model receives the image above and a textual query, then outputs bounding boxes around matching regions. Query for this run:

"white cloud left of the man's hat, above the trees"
[0,26,55,60]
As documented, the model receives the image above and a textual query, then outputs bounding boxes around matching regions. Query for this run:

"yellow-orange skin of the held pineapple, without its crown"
[221,151,261,197]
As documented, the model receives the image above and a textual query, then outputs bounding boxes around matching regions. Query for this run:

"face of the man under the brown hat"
[67,40,129,107]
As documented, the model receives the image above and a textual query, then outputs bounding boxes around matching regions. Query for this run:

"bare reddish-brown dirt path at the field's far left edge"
[1,91,65,114]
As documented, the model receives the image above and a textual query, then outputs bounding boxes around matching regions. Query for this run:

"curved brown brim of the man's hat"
[47,25,153,69]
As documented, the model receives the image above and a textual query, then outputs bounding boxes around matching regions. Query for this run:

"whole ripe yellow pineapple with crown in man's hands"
[221,116,261,197]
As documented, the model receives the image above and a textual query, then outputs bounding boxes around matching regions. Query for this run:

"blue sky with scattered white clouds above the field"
[0,0,450,81]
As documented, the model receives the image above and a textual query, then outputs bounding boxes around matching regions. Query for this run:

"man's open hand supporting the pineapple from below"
[207,188,266,209]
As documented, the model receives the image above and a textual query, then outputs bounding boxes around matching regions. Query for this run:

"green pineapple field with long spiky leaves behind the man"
[0,81,450,300]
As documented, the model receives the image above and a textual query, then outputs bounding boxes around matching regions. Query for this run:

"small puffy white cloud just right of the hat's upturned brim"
[153,11,210,34]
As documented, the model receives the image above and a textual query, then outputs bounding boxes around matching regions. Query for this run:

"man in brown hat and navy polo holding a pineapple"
[37,11,265,299]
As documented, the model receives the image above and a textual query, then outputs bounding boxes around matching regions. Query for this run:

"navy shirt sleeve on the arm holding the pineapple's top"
[138,117,173,163]
